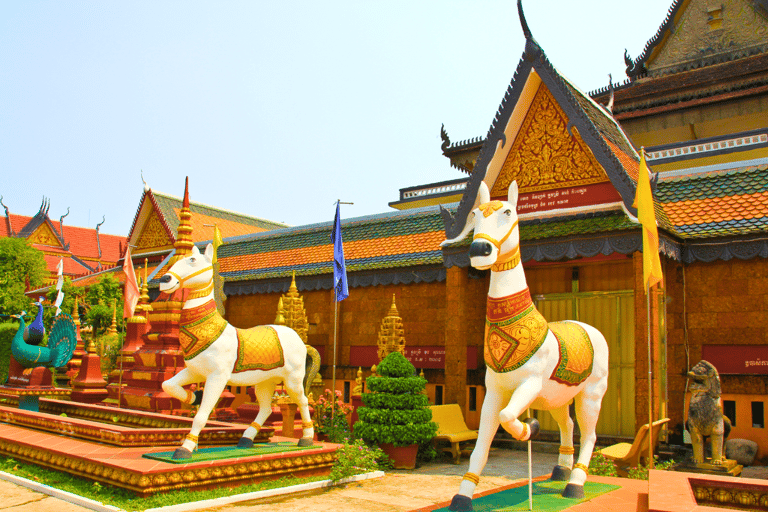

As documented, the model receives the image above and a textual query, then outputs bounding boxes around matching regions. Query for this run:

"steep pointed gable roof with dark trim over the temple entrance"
[444,6,639,242]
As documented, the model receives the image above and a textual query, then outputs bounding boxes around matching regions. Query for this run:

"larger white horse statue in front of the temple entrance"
[443,181,608,510]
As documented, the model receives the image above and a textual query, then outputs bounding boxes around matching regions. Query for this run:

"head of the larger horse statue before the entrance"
[441,181,520,270]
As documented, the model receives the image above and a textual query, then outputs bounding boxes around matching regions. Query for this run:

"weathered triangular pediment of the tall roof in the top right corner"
[646,0,768,75]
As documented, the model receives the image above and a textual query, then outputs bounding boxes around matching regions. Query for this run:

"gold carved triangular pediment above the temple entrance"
[491,85,609,197]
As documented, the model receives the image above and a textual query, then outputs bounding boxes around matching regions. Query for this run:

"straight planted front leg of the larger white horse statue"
[449,382,509,511]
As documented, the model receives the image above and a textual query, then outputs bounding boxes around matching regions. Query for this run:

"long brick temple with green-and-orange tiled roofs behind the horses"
[19,0,768,456]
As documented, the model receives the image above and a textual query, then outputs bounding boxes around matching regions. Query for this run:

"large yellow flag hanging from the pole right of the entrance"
[632,149,662,293]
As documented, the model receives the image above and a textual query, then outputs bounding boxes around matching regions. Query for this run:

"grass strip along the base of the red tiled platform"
[0,457,328,511]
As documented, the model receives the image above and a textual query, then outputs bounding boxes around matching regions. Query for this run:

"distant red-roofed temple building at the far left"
[0,199,126,284]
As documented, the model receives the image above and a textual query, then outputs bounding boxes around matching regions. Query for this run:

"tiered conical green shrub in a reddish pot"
[354,352,437,469]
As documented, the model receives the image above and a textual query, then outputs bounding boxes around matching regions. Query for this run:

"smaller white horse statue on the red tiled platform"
[160,244,320,459]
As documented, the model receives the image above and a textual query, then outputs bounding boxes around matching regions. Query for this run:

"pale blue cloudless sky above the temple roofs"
[0,0,672,235]
